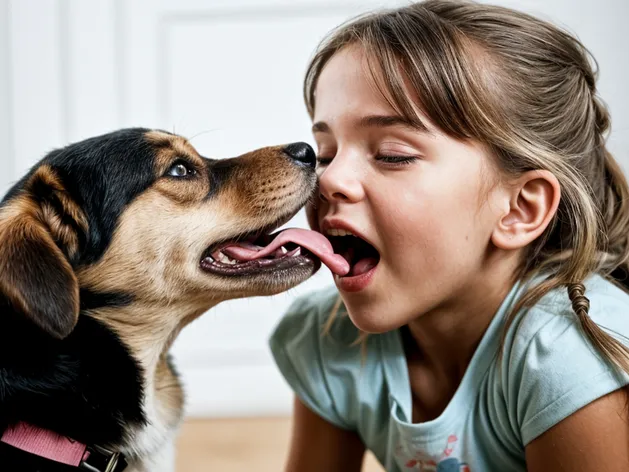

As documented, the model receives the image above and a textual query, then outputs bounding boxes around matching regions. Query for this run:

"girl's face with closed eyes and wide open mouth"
[309,47,508,332]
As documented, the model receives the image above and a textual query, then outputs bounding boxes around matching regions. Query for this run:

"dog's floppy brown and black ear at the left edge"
[0,166,87,339]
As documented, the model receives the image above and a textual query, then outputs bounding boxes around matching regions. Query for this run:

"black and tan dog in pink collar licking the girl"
[0,128,344,472]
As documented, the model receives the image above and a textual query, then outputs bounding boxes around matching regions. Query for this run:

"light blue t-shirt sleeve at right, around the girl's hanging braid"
[506,284,629,446]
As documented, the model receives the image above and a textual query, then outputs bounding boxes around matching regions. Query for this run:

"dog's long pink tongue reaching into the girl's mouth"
[221,228,349,275]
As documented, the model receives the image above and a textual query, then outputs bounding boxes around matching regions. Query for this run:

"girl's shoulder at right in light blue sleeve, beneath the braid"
[495,275,629,445]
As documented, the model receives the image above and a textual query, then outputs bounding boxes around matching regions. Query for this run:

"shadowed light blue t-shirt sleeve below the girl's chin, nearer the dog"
[269,292,353,429]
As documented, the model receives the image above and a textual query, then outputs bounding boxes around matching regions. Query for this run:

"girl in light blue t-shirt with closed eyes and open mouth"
[271,0,629,472]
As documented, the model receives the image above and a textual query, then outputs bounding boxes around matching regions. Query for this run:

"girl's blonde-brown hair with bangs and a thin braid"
[304,0,629,373]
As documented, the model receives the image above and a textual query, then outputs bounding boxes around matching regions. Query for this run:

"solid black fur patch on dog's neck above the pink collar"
[0,307,146,446]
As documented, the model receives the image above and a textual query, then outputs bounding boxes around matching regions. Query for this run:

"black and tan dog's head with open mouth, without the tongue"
[0,128,319,338]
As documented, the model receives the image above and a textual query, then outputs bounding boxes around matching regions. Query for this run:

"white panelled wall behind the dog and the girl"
[0,0,629,416]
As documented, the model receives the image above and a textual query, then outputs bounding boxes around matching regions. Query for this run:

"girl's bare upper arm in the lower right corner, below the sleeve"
[526,389,629,472]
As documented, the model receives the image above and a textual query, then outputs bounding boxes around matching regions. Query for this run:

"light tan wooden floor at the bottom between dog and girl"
[177,418,384,472]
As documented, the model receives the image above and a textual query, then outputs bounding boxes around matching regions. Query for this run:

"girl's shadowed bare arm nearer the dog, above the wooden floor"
[286,397,365,472]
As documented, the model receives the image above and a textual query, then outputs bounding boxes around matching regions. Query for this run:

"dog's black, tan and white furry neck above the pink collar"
[0,296,218,457]
